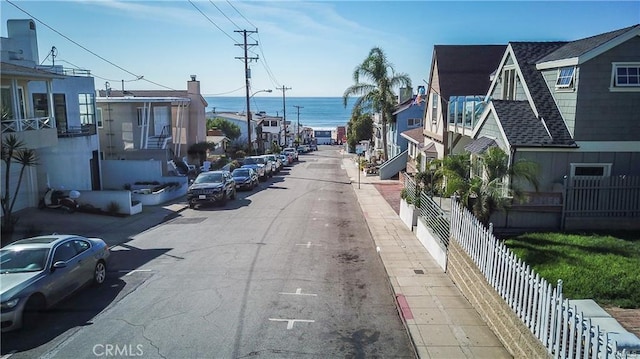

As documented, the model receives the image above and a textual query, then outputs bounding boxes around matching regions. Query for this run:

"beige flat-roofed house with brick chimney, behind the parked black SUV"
[96,75,207,161]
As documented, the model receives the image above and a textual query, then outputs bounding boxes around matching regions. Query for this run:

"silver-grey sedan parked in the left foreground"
[0,234,109,332]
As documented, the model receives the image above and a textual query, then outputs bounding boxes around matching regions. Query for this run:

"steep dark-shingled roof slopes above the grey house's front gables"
[508,42,576,146]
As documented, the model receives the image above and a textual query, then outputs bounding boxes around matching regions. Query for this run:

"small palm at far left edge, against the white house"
[0,135,38,233]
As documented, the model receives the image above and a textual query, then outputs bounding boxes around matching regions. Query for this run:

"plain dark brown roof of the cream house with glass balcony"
[433,45,506,99]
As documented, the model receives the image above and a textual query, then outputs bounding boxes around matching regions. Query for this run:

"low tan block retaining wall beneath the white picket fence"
[447,240,551,358]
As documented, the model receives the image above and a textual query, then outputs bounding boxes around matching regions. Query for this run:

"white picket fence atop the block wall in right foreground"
[450,198,637,359]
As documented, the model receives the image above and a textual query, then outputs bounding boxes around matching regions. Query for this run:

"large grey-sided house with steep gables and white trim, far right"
[464,25,640,227]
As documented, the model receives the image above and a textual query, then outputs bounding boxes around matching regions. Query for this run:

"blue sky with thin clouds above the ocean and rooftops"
[0,0,640,97]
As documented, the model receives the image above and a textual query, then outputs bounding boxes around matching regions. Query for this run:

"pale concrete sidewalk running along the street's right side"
[343,158,512,358]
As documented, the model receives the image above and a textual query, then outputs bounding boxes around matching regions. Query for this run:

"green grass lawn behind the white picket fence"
[505,232,640,308]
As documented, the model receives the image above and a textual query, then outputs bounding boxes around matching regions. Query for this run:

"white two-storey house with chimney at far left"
[0,19,102,211]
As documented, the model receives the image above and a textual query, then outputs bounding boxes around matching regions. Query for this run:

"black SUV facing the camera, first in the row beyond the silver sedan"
[187,171,236,208]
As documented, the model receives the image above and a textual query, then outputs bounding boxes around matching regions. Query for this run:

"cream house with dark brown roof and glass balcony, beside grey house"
[401,45,506,180]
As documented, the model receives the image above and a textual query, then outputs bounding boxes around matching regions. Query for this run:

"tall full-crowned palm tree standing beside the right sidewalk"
[342,47,411,160]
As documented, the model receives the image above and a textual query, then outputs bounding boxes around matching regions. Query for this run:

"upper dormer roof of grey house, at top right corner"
[538,24,640,69]
